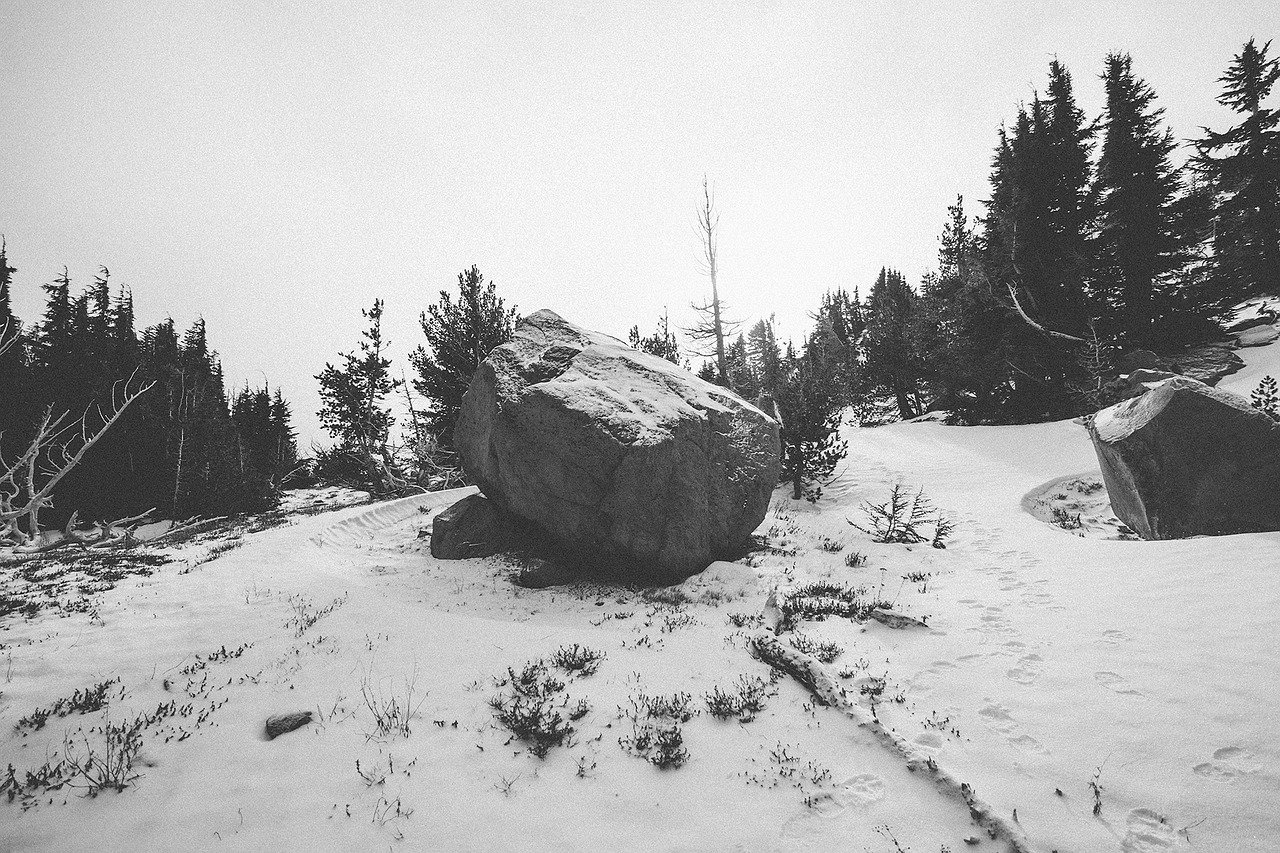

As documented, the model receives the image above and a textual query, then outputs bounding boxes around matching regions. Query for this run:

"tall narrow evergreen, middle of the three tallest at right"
[1096,54,1183,343]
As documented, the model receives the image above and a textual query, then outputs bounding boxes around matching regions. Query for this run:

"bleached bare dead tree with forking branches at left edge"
[0,371,155,544]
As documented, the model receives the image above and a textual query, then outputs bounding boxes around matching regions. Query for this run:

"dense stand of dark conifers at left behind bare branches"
[0,250,296,524]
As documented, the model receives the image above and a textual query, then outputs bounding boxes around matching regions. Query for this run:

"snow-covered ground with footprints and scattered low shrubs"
[0,335,1280,853]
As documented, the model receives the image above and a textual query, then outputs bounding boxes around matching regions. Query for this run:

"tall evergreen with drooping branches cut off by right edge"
[1197,38,1280,304]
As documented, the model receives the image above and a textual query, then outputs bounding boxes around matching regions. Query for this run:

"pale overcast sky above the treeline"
[0,0,1280,447]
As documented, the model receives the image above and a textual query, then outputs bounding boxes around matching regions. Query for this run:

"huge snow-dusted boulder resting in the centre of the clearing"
[454,310,780,580]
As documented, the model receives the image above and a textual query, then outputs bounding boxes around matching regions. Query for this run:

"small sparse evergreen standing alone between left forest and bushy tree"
[316,300,399,459]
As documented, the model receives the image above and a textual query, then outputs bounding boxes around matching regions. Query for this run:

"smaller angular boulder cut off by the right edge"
[1089,377,1280,539]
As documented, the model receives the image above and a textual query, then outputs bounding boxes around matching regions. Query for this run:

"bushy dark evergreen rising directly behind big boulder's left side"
[410,266,518,448]
